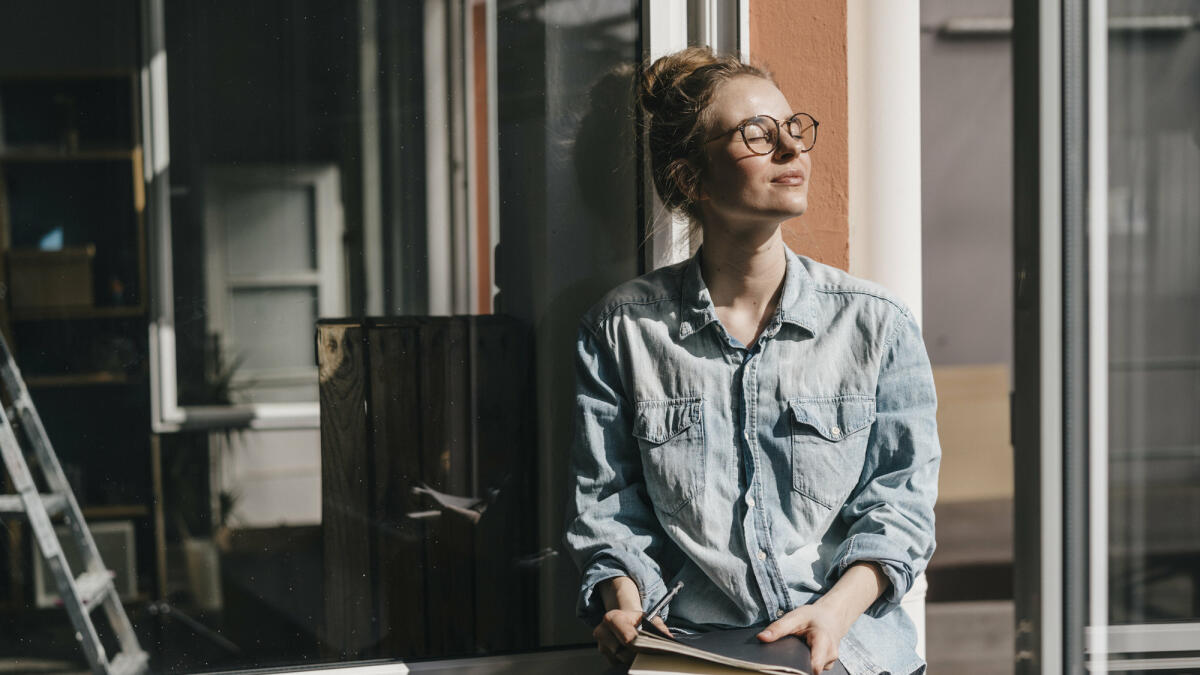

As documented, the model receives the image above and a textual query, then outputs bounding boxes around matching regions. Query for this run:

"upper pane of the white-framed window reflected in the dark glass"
[214,184,317,276]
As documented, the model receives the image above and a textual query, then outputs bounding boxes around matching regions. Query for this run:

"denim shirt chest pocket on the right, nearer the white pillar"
[787,396,875,508]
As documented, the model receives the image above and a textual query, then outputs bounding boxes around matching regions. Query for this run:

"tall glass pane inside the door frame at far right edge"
[1109,0,1200,623]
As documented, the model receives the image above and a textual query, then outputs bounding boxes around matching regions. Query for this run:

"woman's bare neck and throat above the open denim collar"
[700,226,787,318]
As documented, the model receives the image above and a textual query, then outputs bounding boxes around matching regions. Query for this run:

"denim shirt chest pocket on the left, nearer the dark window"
[634,396,706,514]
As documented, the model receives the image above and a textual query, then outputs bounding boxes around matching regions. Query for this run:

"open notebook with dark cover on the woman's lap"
[629,626,848,675]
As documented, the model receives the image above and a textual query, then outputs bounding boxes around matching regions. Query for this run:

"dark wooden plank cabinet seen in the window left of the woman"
[317,316,538,658]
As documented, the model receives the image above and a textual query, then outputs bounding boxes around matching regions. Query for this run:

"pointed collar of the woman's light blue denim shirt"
[679,241,816,340]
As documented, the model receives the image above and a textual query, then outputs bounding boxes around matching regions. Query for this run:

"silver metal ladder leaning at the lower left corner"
[0,335,149,675]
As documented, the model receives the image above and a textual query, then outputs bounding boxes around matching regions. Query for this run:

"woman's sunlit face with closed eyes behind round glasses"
[700,76,812,229]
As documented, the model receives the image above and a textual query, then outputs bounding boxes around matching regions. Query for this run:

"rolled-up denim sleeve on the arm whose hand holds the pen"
[563,324,672,625]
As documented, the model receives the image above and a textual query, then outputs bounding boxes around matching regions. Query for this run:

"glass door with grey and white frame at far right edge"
[1013,0,1200,673]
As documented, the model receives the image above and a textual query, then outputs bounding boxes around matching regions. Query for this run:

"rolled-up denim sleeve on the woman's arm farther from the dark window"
[827,311,942,617]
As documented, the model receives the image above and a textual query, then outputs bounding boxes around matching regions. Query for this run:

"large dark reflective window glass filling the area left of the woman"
[0,0,643,673]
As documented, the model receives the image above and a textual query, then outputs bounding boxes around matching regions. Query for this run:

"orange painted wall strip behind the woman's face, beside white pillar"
[750,0,850,269]
